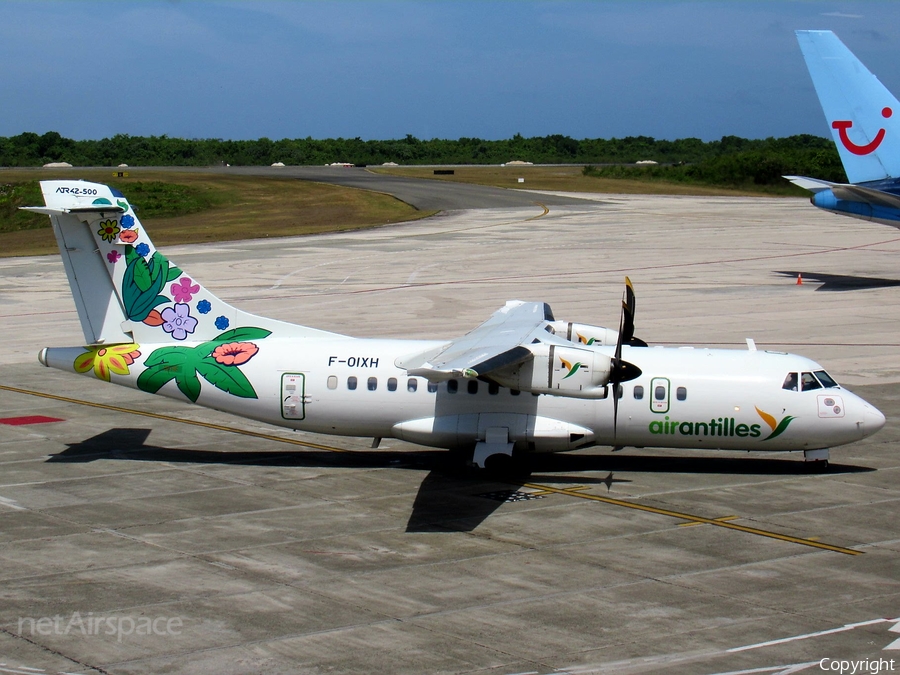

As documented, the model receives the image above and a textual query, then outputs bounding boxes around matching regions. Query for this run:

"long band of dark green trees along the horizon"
[0,131,846,185]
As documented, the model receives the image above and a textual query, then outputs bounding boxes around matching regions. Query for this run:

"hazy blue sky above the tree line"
[0,0,900,141]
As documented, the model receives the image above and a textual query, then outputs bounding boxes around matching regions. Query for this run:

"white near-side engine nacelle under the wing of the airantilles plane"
[489,343,612,398]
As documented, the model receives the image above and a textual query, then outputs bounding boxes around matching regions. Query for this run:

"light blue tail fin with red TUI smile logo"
[796,30,900,183]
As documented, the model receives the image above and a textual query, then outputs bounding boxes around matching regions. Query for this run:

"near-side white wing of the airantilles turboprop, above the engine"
[396,300,553,382]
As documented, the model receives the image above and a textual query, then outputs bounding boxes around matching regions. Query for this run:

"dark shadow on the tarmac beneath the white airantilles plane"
[47,428,874,532]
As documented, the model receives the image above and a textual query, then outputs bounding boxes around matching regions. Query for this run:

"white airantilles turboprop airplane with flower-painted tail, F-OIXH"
[28,180,885,468]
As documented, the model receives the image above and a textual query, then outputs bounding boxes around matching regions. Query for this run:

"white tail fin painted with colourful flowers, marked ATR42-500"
[27,180,337,345]
